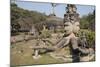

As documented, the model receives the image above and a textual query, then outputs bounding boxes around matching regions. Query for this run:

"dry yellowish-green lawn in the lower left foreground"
[11,41,68,66]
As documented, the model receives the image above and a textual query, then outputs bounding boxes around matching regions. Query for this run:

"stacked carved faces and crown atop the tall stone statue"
[64,4,80,34]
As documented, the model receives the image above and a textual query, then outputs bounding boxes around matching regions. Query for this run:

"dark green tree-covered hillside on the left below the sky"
[11,3,46,31]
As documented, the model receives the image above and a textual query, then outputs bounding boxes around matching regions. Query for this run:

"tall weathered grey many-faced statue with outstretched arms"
[32,4,94,62]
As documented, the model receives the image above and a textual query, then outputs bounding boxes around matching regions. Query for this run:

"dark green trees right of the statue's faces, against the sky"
[80,11,95,31]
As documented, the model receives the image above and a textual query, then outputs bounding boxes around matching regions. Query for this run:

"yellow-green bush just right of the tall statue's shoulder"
[78,29,95,47]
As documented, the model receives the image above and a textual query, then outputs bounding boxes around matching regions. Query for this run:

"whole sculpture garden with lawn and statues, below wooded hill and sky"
[10,1,95,66]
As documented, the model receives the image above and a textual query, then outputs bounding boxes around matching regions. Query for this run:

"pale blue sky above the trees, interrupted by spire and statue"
[16,1,95,18]
